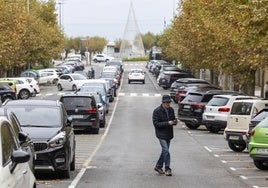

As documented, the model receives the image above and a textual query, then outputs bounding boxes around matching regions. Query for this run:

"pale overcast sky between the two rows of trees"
[57,0,177,41]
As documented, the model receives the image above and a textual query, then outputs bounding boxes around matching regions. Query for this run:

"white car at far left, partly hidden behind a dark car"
[1,77,35,99]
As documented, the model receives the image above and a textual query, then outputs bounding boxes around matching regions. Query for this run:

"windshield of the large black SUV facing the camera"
[8,106,61,127]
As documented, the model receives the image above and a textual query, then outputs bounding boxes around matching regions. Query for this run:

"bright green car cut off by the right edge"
[249,117,268,170]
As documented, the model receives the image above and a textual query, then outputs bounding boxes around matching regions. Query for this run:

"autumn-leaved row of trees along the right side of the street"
[158,0,268,94]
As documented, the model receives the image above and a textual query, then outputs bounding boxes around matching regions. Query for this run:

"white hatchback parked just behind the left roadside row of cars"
[57,73,89,91]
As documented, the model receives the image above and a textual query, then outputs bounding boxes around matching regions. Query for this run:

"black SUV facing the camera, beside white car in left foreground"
[2,100,75,178]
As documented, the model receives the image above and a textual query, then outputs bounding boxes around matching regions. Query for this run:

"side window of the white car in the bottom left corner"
[1,123,18,166]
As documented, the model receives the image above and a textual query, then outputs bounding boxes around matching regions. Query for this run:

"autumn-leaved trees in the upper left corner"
[0,0,64,76]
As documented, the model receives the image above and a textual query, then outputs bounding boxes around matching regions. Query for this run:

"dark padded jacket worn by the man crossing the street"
[152,105,175,140]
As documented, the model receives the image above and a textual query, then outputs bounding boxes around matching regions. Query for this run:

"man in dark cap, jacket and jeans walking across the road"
[152,95,177,176]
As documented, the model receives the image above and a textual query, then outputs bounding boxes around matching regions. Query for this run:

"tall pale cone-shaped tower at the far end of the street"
[120,2,145,58]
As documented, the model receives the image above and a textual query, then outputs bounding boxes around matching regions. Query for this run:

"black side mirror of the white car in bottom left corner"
[9,150,30,173]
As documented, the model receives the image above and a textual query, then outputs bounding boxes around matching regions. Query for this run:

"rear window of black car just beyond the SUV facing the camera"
[61,96,94,110]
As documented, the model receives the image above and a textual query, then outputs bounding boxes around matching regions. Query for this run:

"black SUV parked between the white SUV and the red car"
[178,90,243,129]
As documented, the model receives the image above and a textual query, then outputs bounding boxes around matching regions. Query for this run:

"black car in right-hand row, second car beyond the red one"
[157,71,194,89]
